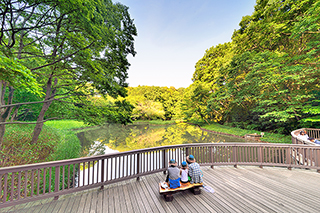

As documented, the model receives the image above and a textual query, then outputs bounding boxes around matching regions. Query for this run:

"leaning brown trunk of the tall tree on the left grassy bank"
[31,75,58,144]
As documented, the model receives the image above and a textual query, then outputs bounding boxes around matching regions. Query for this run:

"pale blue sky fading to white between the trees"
[114,0,255,88]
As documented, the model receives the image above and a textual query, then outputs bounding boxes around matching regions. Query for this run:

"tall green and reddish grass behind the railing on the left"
[0,120,87,167]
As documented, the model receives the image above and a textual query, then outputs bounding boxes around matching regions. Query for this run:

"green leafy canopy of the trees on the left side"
[0,0,137,143]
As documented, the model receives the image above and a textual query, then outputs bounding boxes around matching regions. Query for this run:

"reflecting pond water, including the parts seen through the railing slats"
[76,123,245,186]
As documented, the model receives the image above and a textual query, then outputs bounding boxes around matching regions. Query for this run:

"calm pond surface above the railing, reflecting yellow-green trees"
[78,123,245,156]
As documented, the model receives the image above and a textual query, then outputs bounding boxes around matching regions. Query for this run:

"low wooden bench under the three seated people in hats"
[159,182,203,202]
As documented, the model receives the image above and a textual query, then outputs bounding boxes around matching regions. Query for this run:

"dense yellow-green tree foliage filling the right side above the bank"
[188,0,320,134]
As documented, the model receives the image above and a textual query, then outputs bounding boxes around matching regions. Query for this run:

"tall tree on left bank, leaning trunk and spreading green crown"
[1,0,136,146]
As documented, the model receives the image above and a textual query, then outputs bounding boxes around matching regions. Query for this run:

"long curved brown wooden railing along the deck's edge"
[0,143,320,208]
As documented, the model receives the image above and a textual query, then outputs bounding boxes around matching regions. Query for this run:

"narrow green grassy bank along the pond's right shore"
[199,123,291,143]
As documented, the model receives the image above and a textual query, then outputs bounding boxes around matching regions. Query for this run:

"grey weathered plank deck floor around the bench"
[0,166,320,213]
